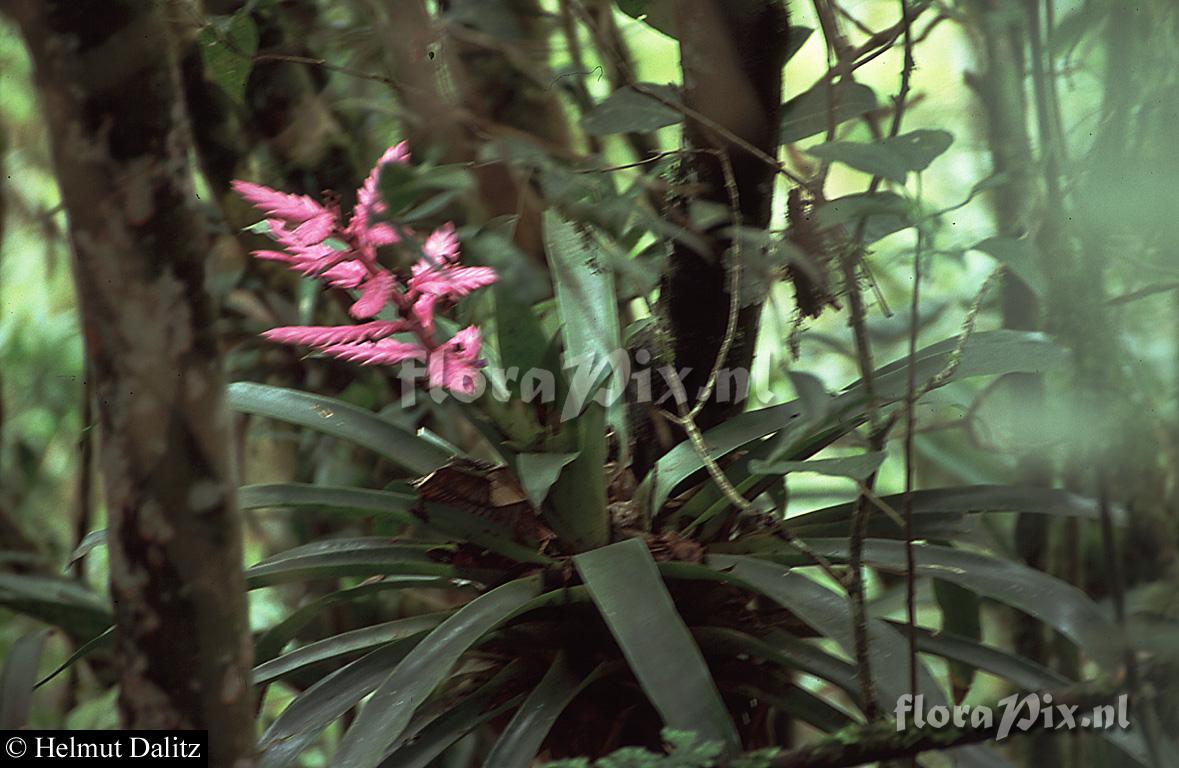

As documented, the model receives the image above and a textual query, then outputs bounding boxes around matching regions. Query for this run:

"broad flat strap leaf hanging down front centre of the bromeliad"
[573,539,740,753]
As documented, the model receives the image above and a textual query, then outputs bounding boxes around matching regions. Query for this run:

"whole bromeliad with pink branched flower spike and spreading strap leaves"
[214,145,1160,768]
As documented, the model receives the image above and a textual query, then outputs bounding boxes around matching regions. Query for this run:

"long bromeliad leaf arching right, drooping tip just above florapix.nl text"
[808,538,1125,669]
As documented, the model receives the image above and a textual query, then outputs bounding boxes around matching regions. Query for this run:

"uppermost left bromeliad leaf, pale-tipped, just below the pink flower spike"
[229,382,452,475]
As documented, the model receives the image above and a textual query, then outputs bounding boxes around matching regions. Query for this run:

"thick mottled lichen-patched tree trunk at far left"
[5,0,253,767]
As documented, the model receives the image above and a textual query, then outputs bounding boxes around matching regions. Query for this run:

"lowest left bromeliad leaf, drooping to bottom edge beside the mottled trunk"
[258,639,417,768]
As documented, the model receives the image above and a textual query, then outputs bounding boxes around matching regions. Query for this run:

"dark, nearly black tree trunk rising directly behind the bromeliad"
[661,0,789,428]
